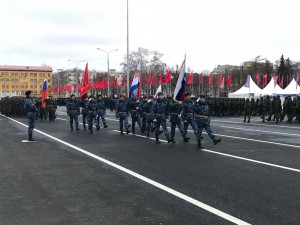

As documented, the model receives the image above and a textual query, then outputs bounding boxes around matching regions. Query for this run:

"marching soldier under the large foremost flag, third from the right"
[169,100,190,143]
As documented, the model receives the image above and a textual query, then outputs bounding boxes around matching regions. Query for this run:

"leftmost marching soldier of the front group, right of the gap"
[116,95,130,135]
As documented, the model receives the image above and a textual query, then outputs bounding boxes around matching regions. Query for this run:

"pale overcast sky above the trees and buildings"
[0,0,300,72]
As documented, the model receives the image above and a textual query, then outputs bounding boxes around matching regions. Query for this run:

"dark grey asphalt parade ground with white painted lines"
[0,107,300,225]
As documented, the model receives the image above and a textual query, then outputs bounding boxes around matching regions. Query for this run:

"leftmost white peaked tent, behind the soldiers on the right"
[228,76,262,98]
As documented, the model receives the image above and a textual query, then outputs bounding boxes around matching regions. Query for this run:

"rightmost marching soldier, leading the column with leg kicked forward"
[192,94,222,149]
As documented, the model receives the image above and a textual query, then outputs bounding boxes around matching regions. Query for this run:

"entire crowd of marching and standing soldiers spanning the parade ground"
[0,91,300,148]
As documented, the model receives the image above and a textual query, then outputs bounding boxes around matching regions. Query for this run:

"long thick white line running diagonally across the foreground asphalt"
[2,115,250,225]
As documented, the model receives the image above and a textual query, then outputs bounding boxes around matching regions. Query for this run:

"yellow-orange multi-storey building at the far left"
[0,65,53,97]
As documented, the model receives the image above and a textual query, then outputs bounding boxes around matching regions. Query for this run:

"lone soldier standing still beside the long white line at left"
[24,91,38,141]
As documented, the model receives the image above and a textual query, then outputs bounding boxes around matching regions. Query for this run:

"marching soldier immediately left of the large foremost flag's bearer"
[152,92,171,144]
